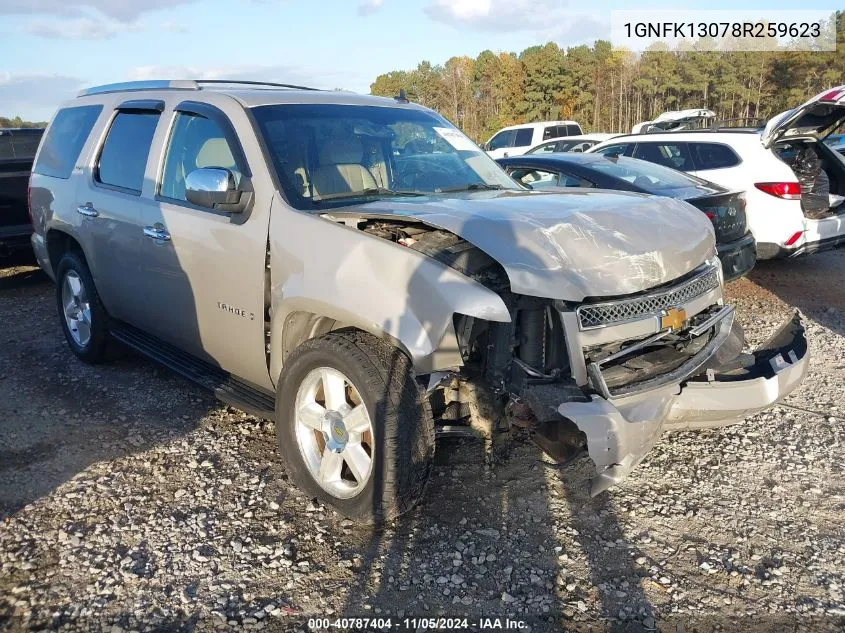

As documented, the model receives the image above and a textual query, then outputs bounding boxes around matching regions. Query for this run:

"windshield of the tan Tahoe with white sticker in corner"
[253,104,519,211]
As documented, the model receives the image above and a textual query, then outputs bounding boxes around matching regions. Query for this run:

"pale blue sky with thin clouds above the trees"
[0,0,835,120]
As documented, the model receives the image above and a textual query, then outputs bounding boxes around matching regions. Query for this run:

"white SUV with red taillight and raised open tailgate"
[587,86,845,259]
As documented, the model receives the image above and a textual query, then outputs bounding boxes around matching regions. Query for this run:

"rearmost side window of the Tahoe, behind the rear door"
[33,105,103,178]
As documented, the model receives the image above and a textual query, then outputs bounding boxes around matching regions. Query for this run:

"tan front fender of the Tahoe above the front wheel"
[269,194,510,379]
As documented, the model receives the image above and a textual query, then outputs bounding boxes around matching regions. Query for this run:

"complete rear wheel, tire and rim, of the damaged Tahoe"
[56,251,110,364]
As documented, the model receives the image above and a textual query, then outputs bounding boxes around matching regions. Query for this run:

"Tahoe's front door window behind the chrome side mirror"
[159,112,241,201]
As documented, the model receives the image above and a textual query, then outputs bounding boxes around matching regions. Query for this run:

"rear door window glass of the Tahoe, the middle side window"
[94,111,159,194]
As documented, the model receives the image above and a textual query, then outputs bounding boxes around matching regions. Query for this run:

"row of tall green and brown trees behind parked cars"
[370,11,845,142]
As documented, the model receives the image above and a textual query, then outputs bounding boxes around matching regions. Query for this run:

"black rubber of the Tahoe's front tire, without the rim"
[276,330,434,524]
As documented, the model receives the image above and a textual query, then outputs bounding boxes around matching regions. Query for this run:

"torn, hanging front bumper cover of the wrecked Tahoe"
[558,312,809,495]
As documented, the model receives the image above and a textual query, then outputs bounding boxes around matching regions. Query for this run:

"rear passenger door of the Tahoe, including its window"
[75,101,163,325]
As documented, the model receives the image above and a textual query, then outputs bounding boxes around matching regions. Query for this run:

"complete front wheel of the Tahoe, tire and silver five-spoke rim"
[276,330,434,523]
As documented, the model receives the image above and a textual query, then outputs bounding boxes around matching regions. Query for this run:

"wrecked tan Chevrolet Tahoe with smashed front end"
[31,81,808,521]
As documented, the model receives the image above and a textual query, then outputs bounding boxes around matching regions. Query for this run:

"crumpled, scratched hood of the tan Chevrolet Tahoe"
[327,190,715,301]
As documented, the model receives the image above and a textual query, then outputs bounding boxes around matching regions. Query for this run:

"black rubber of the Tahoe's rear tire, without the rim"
[56,251,111,365]
